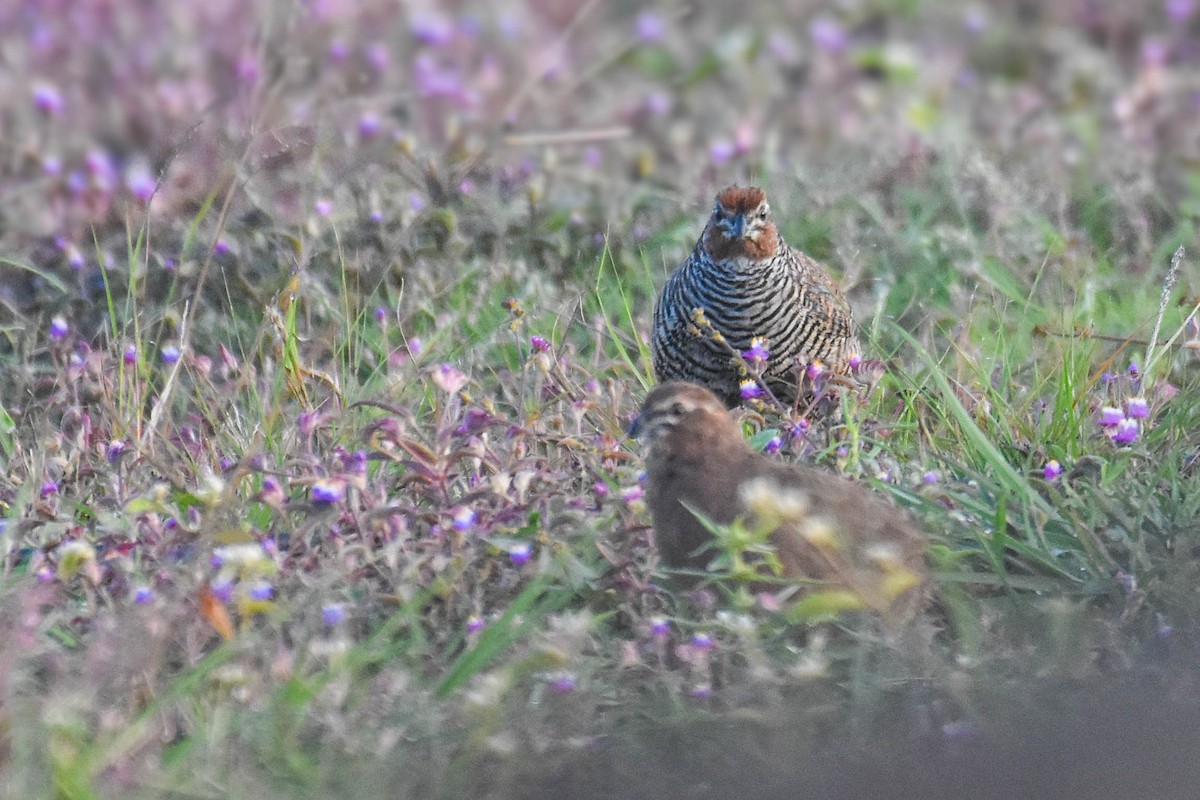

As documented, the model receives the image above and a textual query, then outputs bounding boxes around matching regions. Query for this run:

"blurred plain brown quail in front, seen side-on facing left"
[630,381,926,616]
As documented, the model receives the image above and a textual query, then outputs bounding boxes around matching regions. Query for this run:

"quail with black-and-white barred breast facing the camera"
[653,186,859,407]
